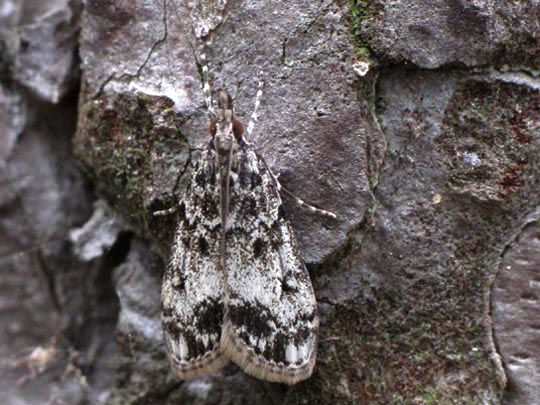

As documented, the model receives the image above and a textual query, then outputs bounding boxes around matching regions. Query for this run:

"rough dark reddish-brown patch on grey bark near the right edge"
[440,81,540,201]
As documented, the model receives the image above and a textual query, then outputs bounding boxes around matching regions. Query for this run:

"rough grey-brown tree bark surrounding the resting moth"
[0,0,540,404]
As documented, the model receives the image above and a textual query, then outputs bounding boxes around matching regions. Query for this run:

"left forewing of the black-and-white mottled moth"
[161,150,229,379]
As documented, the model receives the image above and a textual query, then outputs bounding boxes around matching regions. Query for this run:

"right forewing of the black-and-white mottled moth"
[222,147,319,384]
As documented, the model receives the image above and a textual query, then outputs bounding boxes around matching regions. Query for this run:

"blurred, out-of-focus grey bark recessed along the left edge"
[0,0,122,404]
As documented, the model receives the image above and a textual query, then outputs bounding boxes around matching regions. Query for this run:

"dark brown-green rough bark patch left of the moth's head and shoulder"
[75,94,189,252]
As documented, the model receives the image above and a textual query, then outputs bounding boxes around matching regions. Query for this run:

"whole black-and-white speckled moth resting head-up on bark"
[161,91,319,384]
